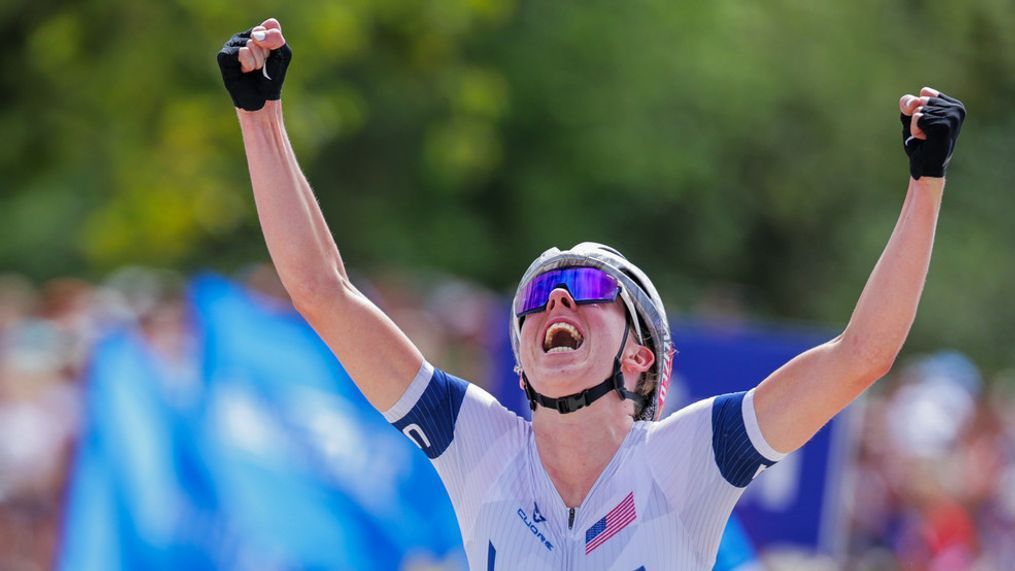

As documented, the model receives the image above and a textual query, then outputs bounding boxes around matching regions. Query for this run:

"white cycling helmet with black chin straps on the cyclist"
[511,242,675,420]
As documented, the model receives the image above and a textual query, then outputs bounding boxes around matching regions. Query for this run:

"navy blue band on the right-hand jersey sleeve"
[712,392,775,488]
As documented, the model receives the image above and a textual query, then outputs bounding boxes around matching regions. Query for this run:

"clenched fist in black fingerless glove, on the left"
[218,18,292,111]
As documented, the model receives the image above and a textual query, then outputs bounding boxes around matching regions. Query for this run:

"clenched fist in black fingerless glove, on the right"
[898,87,965,181]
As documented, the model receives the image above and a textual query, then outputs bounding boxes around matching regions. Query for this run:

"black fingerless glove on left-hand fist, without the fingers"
[218,28,292,111]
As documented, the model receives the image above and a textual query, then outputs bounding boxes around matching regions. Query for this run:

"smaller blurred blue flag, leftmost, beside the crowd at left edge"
[59,331,218,570]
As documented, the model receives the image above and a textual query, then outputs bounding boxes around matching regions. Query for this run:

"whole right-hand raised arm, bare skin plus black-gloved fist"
[754,87,965,452]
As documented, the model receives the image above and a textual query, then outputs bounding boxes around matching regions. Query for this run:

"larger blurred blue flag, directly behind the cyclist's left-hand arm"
[193,277,461,569]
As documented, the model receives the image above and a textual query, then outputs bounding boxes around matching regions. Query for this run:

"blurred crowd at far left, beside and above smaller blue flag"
[0,270,185,571]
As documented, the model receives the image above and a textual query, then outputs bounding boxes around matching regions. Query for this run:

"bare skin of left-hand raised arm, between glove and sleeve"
[238,101,423,411]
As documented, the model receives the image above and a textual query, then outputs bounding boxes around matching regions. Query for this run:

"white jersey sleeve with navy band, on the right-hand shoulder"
[646,389,786,561]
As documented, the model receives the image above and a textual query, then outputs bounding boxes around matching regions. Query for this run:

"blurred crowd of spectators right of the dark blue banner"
[845,352,1015,571]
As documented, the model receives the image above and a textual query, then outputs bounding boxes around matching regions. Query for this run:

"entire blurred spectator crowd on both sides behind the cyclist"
[0,266,1015,571]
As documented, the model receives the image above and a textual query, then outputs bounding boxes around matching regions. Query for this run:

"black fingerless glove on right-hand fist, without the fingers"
[900,93,965,181]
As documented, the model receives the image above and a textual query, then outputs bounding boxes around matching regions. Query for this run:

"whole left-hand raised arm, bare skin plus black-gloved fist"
[218,18,423,411]
